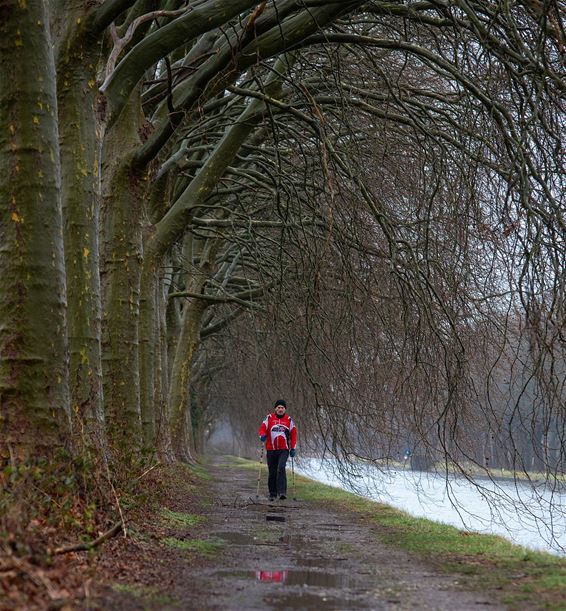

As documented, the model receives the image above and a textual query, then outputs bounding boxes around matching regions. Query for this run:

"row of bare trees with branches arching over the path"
[0,0,566,488]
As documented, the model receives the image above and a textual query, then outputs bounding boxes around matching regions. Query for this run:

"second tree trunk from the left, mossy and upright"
[57,16,106,456]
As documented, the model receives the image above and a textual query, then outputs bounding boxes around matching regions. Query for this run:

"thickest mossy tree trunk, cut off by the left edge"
[0,0,70,461]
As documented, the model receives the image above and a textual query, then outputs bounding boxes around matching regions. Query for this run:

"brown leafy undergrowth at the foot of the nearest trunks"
[0,450,173,610]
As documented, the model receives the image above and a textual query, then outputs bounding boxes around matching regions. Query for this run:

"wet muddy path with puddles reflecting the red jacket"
[92,458,504,611]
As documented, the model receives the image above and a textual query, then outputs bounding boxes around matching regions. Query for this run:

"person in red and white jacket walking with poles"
[259,399,297,501]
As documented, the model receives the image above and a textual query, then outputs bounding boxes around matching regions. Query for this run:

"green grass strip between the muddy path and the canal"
[231,458,566,610]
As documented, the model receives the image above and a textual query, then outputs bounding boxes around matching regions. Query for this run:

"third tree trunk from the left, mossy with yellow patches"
[101,101,143,456]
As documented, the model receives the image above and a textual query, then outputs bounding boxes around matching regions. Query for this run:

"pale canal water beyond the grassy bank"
[295,458,566,556]
